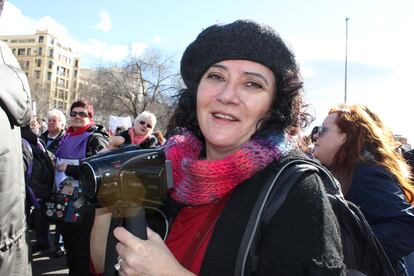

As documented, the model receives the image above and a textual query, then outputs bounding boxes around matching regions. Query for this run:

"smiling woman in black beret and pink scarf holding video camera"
[92,20,345,275]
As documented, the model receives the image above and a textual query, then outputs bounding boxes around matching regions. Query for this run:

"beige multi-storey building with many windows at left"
[0,30,79,117]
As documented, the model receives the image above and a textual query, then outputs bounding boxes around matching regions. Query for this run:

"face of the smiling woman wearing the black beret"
[197,60,276,160]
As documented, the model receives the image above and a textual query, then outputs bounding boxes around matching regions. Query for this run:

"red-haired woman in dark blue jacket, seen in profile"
[313,105,414,275]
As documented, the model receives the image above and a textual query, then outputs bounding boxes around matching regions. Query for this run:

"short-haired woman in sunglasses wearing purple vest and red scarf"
[55,101,108,275]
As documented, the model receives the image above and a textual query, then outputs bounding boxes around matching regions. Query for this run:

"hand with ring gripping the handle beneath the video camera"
[114,227,194,276]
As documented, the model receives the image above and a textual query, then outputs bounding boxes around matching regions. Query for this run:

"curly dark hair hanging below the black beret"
[167,64,311,140]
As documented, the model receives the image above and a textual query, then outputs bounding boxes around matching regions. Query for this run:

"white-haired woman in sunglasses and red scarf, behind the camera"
[109,111,158,149]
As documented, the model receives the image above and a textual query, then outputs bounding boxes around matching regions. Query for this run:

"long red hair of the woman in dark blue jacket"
[329,104,414,204]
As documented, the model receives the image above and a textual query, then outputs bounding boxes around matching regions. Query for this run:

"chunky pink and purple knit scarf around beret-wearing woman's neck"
[165,130,291,206]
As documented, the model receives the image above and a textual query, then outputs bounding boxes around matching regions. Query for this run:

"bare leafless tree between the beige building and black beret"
[80,49,182,130]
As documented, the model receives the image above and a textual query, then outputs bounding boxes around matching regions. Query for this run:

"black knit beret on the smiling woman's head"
[181,20,297,88]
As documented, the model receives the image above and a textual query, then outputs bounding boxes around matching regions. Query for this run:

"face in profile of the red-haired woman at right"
[312,113,346,166]
